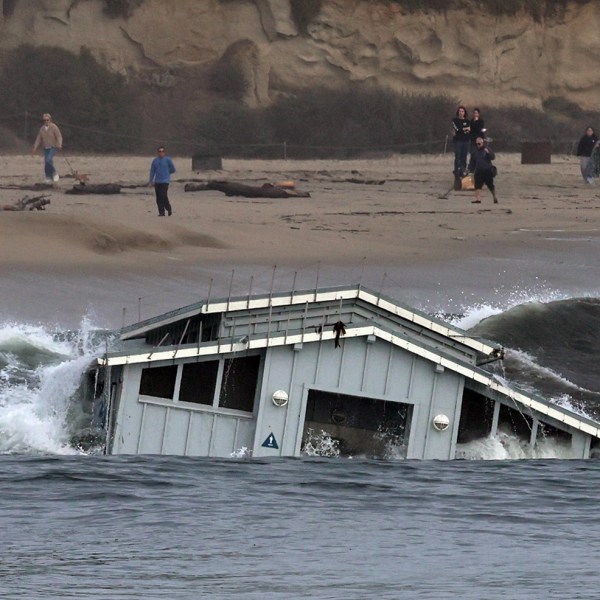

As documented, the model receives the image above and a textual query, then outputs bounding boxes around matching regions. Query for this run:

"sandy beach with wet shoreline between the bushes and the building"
[0,153,600,326]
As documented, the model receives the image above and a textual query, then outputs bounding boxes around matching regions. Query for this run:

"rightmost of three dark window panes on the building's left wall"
[219,355,260,412]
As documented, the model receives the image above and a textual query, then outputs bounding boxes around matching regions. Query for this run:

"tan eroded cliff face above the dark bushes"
[0,0,600,109]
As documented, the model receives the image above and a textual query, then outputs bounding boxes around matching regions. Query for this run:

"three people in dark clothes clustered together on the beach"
[452,106,498,204]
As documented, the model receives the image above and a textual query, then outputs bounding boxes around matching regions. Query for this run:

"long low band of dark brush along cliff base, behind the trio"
[195,84,600,158]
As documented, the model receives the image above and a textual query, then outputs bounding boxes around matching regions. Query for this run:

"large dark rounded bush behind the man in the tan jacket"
[0,45,140,152]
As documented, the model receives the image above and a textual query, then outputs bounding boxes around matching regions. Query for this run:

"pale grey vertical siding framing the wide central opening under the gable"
[253,338,462,458]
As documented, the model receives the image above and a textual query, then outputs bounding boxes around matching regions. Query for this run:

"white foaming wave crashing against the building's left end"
[0,319,99,454]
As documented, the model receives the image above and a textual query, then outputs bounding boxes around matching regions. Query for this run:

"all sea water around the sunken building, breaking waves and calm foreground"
[0,297,600,600]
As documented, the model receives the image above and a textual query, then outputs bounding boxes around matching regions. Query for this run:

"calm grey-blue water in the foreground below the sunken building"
[0,456,600,600]
